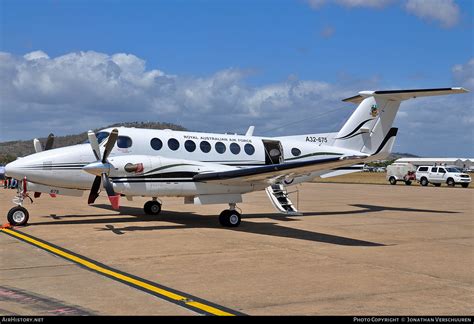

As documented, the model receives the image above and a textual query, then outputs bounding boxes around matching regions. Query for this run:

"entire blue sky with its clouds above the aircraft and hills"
[0,0,474,156]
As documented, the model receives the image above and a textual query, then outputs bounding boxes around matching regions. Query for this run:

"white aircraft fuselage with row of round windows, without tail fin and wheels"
[7,127,360,197]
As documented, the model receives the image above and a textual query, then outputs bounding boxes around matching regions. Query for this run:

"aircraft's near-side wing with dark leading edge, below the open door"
[193,155,367,185]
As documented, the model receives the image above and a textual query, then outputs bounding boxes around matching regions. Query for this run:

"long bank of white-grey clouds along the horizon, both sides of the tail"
[0,51,474,155]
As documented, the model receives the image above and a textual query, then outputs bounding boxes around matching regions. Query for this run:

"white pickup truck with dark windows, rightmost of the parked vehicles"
[416,166,471,188]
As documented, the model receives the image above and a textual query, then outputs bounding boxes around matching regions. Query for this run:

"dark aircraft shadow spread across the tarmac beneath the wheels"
[31,204,457,247]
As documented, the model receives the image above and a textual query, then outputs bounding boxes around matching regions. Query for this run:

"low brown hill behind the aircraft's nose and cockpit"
[0,122,186,164]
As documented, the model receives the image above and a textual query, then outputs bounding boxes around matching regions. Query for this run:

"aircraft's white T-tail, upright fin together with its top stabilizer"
[333,88,468,156]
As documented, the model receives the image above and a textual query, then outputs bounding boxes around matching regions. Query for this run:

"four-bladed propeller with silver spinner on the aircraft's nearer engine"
[83,128,120,209]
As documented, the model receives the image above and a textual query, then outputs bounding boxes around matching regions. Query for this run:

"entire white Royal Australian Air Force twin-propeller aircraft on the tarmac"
[5,88,467,227]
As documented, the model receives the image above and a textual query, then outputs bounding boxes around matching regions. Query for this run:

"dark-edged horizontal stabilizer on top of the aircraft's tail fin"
[342,88,469,104]
